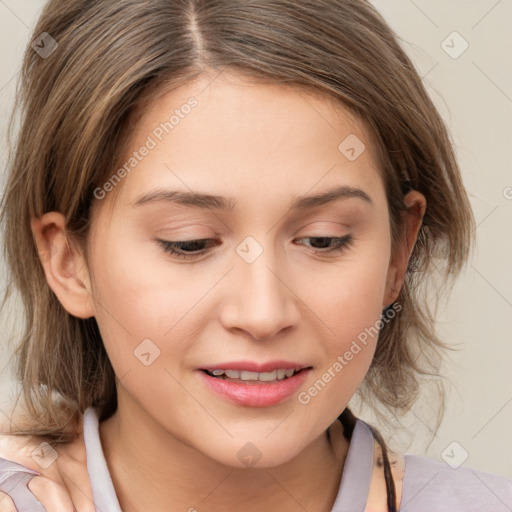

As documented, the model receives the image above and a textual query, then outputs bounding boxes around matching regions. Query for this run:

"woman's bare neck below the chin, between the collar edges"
[100,394,348,512]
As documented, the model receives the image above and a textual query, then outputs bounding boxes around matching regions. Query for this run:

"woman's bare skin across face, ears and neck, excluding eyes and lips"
[26,72,426,512]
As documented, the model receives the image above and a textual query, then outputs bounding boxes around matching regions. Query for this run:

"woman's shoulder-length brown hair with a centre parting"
[0,0,474,510]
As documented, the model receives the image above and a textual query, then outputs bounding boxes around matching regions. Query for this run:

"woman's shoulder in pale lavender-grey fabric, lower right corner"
[400,455,512,512]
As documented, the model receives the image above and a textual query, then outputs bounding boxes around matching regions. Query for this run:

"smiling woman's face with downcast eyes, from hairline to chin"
[73,73,412,466]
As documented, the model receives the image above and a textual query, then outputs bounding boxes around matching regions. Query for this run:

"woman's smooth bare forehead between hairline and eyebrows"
[97,73,380,216]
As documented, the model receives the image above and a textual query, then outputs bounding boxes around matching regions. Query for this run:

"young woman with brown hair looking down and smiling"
[0,0,512,512]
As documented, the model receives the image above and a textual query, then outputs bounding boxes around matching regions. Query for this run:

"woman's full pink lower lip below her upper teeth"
[199,368,310,407]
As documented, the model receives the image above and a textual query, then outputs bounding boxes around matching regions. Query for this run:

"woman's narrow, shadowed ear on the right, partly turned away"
[382,190,427,308]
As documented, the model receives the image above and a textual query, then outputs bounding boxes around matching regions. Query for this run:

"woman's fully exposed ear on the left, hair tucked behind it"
[31,212,94,318]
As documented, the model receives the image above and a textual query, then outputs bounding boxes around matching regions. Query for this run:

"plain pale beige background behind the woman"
[0,0,512,479]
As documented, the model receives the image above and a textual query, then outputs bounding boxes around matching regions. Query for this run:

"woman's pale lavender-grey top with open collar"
[0,408,512,512]
